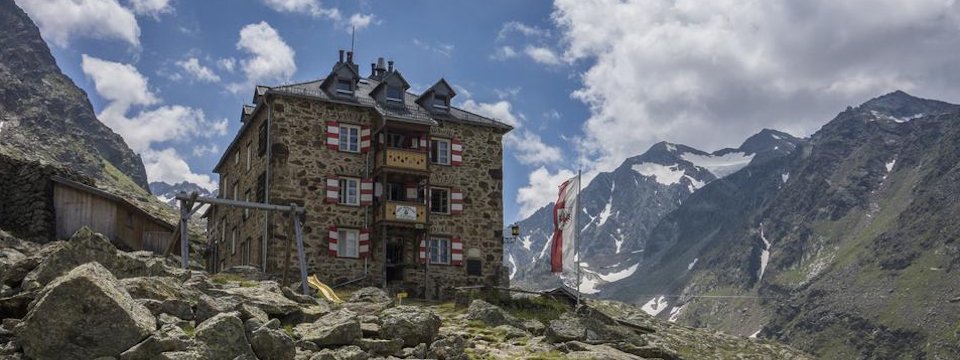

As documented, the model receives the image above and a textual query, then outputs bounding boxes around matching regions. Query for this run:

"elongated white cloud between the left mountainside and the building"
[81,54,227,189]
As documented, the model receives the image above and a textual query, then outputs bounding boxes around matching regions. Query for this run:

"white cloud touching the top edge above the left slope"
[16,0,140,48]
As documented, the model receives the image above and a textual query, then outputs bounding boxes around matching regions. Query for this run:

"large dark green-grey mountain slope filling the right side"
[602,91,960,359]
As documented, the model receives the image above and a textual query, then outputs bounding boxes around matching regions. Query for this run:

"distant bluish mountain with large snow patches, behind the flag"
[505,129,800,293]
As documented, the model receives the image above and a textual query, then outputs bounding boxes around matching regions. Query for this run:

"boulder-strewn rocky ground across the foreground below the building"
[0,228,810,360]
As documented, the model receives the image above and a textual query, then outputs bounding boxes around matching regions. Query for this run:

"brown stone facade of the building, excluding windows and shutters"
[208,54,510,298]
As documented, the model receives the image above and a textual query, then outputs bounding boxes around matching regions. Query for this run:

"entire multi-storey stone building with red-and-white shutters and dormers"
[207,51,512,298]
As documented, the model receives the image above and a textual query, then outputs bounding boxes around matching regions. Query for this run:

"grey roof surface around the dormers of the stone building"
[270,78,513,131]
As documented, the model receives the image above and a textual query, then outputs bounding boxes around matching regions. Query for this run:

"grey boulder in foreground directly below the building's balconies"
[380,305,440,346]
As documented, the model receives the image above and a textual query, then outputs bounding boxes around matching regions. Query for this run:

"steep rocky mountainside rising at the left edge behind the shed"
[0,0,147,190]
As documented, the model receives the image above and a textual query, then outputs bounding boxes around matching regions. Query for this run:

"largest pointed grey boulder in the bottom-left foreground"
[17,263,157,359]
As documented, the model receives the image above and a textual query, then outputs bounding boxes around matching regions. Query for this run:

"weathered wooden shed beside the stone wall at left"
[52,176,179,254]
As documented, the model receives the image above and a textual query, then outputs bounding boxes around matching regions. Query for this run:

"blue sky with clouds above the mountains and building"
[16,0,960,223]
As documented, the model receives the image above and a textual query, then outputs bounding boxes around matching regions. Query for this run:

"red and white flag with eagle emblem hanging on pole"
[550,176,580,279]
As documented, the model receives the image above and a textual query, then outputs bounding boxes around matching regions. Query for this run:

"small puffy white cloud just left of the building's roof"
[228,21,297,92]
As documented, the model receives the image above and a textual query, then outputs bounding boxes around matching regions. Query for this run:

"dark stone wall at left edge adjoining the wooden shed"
[0,154,94,242]
